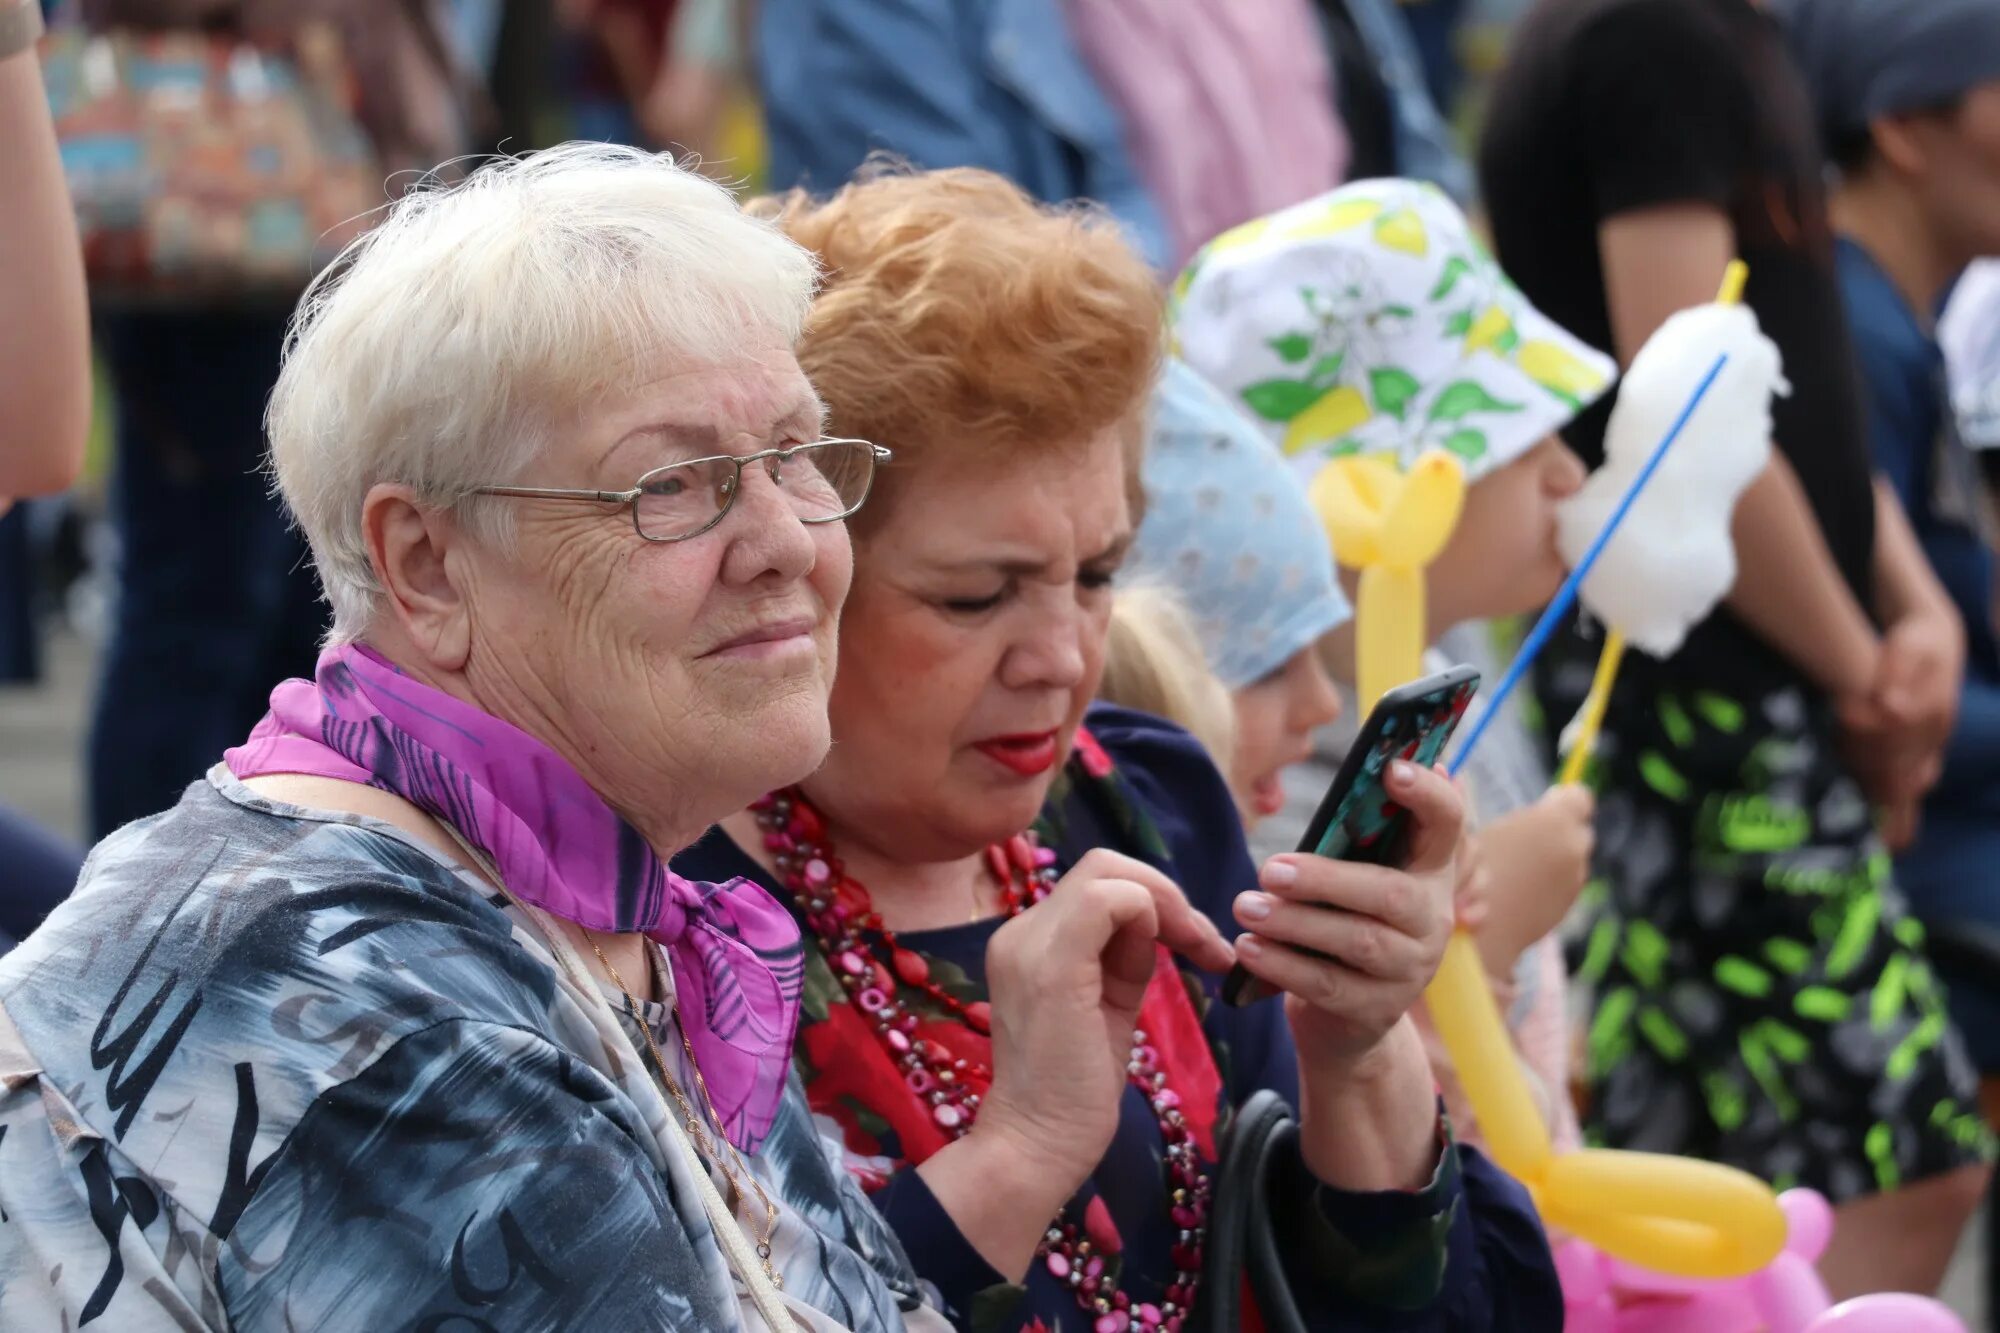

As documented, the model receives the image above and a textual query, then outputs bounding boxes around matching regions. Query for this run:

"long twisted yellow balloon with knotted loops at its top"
[1310,428,1786,1277]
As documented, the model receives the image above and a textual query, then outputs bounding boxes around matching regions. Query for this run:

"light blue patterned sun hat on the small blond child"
[1126,360,1354,691]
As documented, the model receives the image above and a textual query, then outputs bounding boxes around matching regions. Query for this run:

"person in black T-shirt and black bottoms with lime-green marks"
[1480,0,1990,1295]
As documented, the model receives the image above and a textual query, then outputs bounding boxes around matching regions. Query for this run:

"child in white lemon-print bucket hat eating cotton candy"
[1170,180,1616,1143]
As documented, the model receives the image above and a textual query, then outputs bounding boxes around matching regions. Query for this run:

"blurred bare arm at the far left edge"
[0,45,90,496]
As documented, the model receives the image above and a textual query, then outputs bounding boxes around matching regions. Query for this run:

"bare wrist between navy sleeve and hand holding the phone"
[1298,1015,1438,1193]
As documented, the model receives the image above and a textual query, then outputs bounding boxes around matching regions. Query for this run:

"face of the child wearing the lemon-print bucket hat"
[1430,436,1584,630]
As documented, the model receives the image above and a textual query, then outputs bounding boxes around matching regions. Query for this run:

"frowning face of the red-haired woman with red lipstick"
[806,430,1132,863]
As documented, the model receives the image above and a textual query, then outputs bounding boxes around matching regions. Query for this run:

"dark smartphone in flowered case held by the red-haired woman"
[1222,667,1480,1005]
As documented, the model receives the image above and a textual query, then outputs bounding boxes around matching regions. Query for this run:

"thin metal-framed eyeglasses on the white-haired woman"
[472,440,890,542]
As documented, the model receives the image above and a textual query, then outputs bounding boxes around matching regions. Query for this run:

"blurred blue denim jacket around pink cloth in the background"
[756,0,1472,272]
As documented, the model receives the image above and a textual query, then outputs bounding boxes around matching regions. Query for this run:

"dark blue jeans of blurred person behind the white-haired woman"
[88,312,324,839]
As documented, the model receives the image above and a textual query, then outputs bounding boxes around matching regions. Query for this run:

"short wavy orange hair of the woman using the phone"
[750,164,1164,534]
